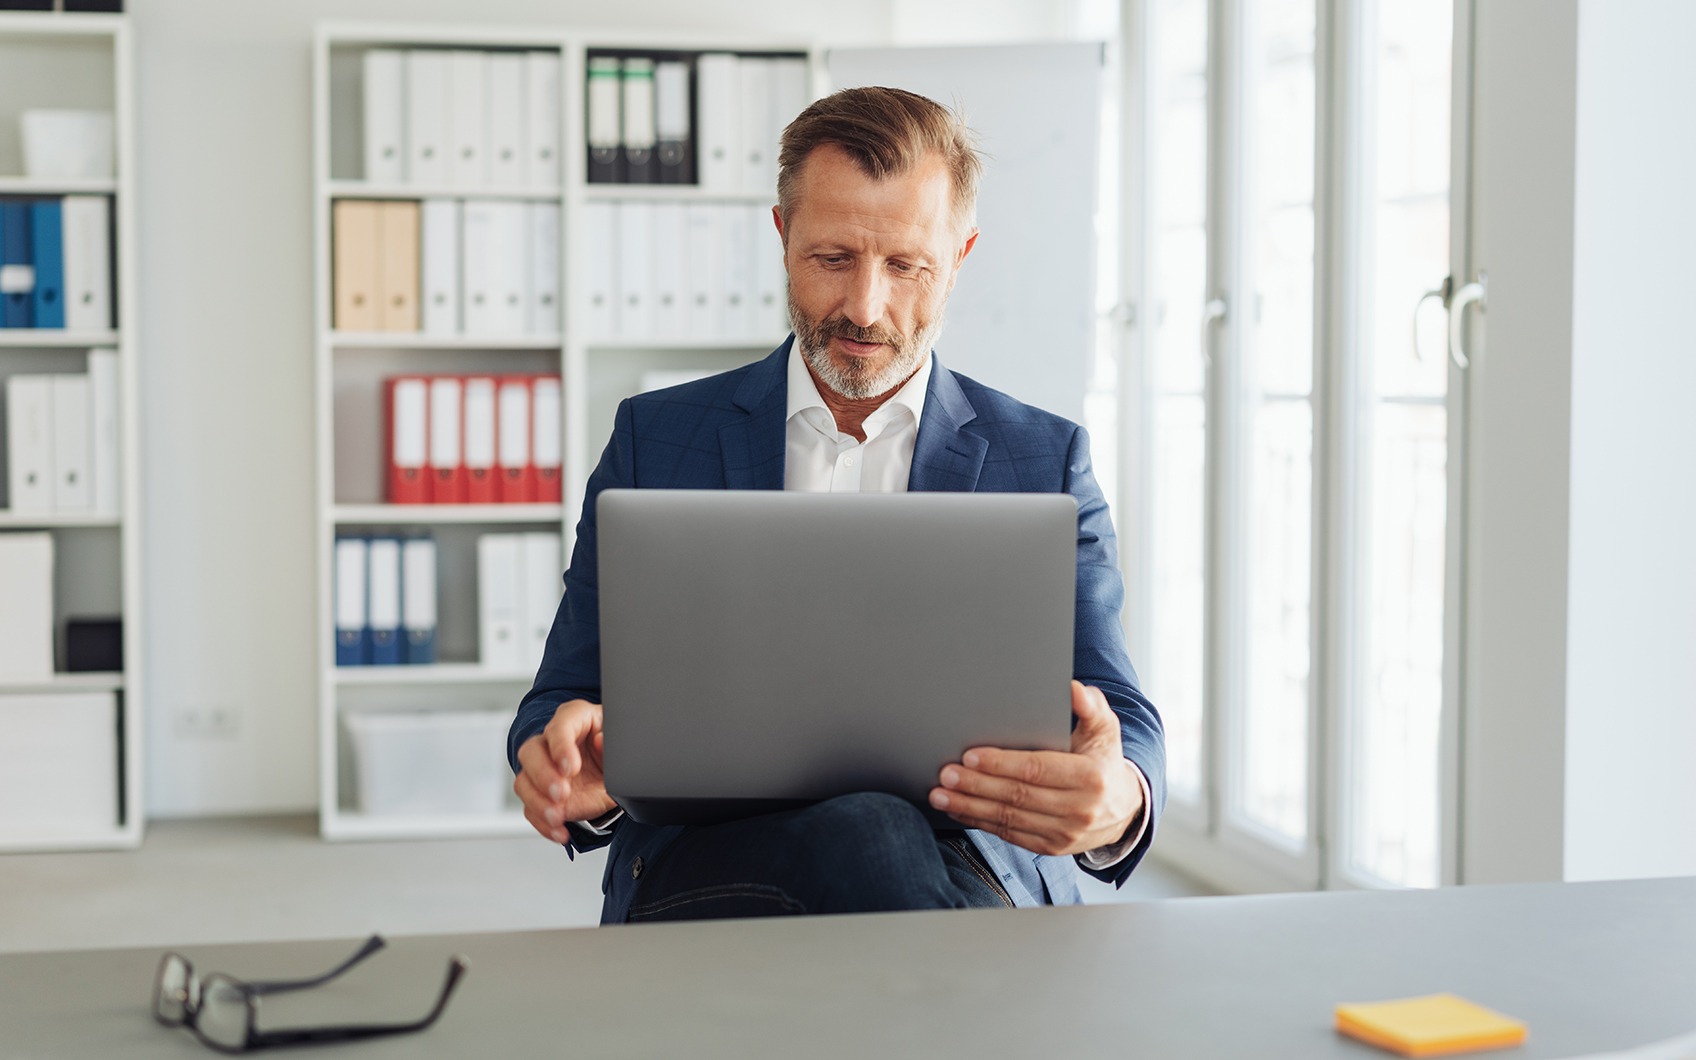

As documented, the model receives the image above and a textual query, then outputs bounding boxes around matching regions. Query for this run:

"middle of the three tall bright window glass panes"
[1231,0,1318,846]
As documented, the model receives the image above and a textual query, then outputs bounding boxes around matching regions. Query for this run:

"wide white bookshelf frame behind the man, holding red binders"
[314,22,821,838]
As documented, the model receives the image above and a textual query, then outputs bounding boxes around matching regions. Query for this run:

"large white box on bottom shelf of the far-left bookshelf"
[0,692,119,843]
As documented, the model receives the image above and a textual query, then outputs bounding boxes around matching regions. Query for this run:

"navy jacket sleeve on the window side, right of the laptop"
[1065,427,1165,885]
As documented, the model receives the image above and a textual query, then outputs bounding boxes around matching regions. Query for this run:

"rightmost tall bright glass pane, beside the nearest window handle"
[1347,0,1453,887]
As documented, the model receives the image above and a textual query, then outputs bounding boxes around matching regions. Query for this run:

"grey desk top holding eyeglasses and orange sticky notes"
[0,879,1696,1060]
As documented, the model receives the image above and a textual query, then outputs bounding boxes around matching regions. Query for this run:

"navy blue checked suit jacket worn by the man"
[507,338,1165,923]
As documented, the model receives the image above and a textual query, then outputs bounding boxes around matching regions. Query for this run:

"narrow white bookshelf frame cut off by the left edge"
[0,12,146,851]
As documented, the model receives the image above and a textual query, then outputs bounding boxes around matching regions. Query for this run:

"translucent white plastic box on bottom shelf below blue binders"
[343,711,512,817]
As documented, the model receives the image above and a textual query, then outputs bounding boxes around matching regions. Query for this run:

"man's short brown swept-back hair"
[777,88,984,232]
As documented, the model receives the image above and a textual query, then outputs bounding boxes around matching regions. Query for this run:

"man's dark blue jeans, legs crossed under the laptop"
[629,792,1011,923]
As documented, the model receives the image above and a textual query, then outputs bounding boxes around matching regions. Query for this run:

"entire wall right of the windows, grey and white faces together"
[1462,0,1696,882]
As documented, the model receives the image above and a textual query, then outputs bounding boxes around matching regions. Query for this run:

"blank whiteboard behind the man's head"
[826,42,1104,422]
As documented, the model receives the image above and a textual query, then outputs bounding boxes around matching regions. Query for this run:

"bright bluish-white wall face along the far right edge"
[1565,0,1696,880]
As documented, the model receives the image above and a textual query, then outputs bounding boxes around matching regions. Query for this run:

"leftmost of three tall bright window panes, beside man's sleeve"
[1141,0,1208,802]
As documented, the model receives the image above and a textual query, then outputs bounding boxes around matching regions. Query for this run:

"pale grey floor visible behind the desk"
[0,816,1211,951]
